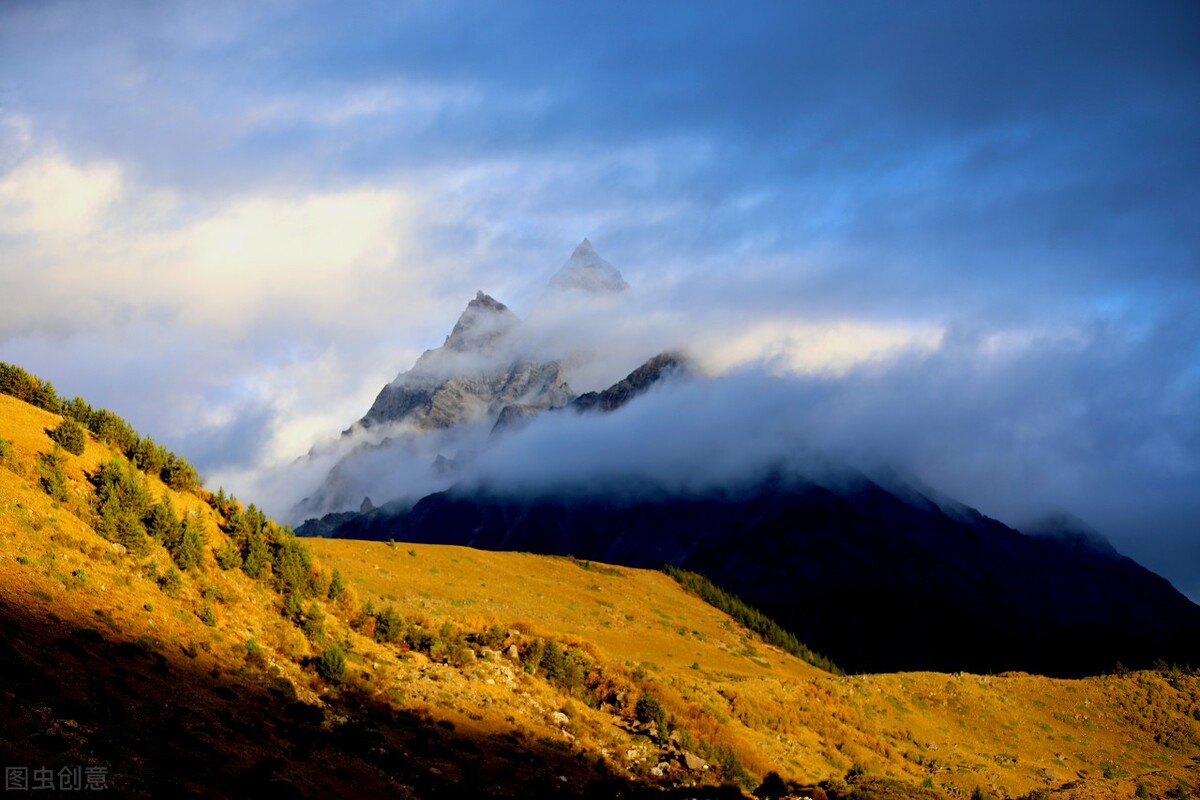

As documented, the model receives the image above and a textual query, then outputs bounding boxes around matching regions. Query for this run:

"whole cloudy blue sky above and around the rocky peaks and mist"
[0,0,1200,597]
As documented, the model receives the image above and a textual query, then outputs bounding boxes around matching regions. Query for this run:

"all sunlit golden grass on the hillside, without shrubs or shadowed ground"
[0,396,1200,798]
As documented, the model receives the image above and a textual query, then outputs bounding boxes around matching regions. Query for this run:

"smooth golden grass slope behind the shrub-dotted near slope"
[311,540,1200,798]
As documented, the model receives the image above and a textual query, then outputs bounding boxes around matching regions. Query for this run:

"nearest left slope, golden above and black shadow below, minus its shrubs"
[0,396,739,798]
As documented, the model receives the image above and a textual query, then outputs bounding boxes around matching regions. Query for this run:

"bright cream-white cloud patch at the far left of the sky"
[0,145,436,337]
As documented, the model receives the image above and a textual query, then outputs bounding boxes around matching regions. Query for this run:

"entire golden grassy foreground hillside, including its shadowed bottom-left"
[0,383,1200,798]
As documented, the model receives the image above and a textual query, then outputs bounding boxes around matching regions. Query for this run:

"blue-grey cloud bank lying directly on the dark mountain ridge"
[453,311,1200,595]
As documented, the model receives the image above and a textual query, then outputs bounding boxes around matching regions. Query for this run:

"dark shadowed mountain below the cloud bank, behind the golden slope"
[324,476,1200,675]
